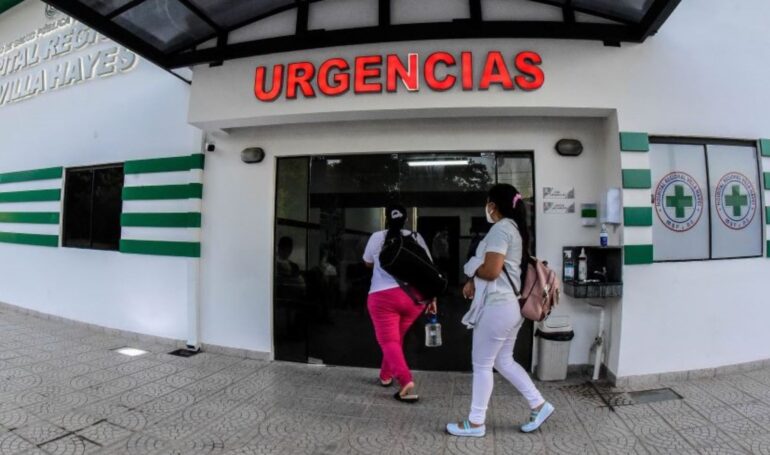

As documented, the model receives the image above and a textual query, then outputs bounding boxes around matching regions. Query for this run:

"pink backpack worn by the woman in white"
[503,257,559,322]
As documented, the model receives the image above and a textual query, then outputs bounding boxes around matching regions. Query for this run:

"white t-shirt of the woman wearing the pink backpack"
[476,218,523,294]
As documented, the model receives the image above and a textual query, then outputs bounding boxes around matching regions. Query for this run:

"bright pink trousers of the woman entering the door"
[367,288,425,387]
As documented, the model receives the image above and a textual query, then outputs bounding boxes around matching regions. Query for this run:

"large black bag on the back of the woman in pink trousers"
[380,233,449,303]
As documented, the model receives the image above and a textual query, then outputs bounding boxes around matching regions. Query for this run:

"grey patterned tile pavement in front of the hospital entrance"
[0,310,770,455]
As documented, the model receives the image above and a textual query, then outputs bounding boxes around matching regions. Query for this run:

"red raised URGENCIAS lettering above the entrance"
[254,51,545,102]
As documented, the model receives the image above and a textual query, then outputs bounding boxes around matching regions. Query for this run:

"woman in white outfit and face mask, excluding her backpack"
[446,184,554,437]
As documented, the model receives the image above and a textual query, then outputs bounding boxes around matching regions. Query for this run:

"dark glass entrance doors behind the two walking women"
[274,153,534,371]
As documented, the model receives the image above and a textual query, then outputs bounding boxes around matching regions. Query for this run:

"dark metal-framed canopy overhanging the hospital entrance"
[45,0,680,70]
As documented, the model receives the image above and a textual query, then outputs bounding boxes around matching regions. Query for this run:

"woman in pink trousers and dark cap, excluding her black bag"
[364,205,436,403]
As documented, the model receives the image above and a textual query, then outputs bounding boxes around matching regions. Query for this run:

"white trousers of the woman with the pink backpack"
[468,301,544,425]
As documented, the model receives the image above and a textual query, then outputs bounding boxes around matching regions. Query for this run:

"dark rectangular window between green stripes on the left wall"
[64,164,123,250]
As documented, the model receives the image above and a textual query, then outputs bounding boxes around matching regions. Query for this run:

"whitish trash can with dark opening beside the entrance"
[535,316,575,381]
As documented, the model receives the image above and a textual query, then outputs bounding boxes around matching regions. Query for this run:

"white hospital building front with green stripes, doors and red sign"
[0,0,770,382]
